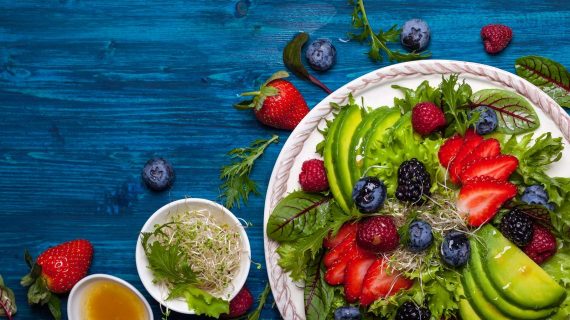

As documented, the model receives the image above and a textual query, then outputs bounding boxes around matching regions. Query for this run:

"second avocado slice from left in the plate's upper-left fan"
[329,104,364,207]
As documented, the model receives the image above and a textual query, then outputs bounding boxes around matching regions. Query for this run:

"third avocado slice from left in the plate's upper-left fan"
[348,107,390,186]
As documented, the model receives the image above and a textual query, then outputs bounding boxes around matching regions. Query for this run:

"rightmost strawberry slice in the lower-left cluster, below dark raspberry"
[360,258,414,306]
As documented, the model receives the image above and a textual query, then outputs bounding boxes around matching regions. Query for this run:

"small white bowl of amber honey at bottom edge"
[67,274,154,320]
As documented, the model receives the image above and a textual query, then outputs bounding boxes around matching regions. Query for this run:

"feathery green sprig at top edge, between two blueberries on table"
[349,0,431,62]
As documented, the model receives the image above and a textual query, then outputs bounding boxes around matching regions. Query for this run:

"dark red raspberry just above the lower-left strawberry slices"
[356,216,400,253]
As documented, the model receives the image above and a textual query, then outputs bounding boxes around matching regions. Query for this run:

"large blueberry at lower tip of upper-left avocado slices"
[352,177,386,213]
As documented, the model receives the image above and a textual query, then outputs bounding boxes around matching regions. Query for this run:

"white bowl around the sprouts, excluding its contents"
[135,198,251,314]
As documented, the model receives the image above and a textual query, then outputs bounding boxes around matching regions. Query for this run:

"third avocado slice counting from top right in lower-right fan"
[461,264,511,320]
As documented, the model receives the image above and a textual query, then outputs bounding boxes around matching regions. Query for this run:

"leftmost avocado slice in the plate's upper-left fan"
[323,108,349,212]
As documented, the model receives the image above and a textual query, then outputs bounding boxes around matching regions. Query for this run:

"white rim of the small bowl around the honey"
[67,274,154,320]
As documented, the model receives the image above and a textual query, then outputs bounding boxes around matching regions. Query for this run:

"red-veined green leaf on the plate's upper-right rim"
[471,89,540,134]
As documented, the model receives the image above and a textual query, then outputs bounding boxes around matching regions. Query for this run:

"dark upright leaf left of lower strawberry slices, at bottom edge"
[304,255,334,320]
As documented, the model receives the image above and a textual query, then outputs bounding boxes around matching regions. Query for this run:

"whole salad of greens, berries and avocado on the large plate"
[267,75,570,320]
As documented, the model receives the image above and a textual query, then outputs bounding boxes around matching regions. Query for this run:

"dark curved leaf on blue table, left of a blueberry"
[283,32,332,93]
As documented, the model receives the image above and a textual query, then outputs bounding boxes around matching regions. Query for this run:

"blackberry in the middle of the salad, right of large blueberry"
[396,158,431,205]
